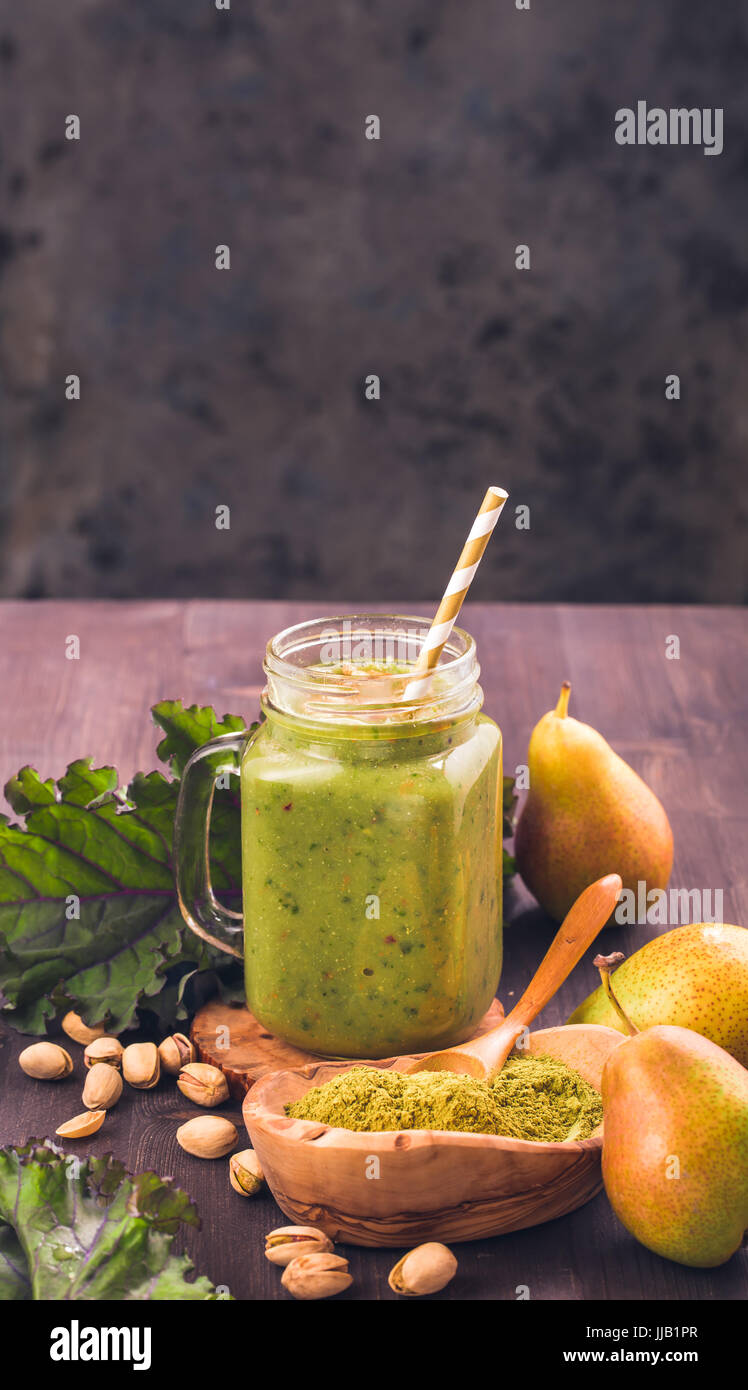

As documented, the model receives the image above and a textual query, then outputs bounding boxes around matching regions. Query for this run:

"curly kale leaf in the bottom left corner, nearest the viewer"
[0,1140,225,1301]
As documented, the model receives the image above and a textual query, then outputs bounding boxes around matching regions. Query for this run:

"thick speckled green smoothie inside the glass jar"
[242,666,502,1059]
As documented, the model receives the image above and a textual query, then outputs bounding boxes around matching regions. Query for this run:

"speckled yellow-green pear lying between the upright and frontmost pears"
[569,922,748,1066]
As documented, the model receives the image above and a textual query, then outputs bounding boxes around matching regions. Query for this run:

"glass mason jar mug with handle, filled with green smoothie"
[175,614,502,1059]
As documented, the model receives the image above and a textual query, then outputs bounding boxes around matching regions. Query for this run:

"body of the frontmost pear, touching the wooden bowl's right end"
[602,1024,748,1268]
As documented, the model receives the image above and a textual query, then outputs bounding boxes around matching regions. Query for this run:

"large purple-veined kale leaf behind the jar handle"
[0,701,243,1033]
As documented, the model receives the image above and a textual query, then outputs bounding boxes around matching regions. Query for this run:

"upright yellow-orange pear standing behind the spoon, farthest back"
[514,681,673,922]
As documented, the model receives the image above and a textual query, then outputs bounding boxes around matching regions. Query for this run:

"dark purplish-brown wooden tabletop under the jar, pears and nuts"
[0,600,748,1300]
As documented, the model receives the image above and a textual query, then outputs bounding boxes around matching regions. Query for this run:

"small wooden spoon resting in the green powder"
[407,873,621,1081]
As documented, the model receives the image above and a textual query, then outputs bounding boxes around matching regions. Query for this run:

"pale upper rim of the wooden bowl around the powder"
[242,1023,626,1155]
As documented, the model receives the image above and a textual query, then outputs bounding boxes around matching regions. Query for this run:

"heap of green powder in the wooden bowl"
[286,1056,602,1143]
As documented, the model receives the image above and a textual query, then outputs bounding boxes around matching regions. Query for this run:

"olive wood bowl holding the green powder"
[243,1023,623,1245]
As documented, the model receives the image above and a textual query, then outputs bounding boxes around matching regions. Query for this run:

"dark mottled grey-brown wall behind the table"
[0,0,748,602]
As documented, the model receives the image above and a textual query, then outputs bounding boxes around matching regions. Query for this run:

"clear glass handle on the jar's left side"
[174,728,257,959]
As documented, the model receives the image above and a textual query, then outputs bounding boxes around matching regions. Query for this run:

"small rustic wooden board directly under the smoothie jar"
[190,999,503,1101]
